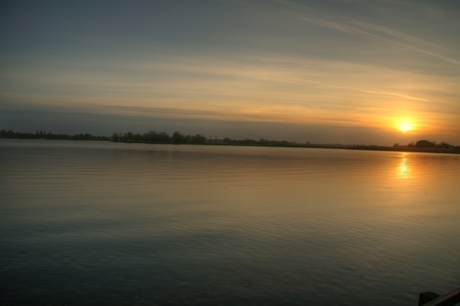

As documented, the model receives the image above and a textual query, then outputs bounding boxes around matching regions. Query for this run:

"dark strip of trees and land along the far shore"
[0,130,460,153]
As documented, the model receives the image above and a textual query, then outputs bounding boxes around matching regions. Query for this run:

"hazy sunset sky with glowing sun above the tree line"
[0,0,460,145]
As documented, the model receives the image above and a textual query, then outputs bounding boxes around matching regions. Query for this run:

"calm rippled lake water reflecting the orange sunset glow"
[0,139,460,305]
